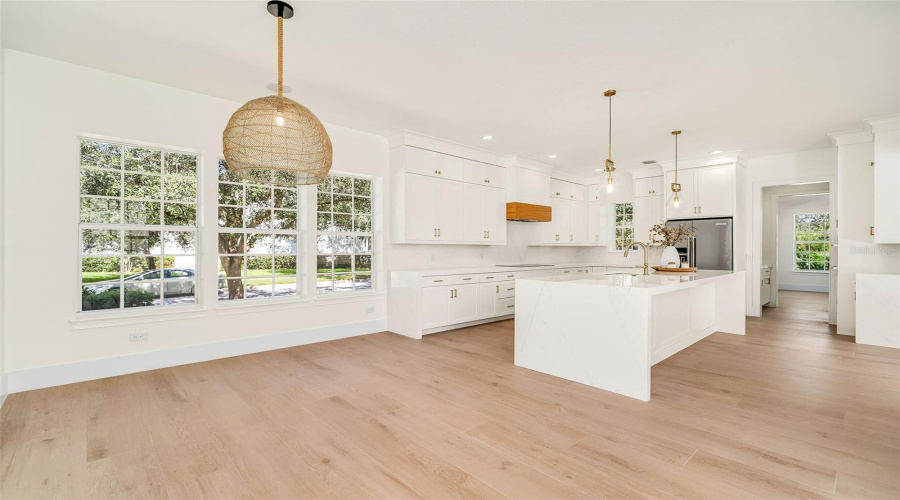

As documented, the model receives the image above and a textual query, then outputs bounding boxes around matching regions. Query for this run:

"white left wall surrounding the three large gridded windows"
[2,50,390,391]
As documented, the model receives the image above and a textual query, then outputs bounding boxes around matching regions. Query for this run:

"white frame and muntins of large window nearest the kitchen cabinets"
[310,170,381,294]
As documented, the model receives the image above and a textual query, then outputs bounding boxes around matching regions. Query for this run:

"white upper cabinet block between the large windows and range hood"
[390,139,510,245]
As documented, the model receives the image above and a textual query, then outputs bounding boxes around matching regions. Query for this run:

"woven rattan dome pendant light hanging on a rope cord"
[222,0,332,186]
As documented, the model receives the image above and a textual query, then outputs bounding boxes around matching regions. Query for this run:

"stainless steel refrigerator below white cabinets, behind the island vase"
[666,217,734,271]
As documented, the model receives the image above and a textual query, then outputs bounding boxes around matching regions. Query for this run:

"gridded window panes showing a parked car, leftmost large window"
[79,139,198,311]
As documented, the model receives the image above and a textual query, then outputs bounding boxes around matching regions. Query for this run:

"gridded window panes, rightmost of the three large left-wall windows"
[316,175,373,293]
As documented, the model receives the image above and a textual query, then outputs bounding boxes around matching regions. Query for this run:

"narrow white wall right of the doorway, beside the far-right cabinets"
[837,134,900,335]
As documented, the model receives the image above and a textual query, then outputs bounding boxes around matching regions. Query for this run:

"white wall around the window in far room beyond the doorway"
[776,192,829,292]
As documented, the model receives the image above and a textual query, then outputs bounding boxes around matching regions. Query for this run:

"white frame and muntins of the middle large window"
[215,156,310,302]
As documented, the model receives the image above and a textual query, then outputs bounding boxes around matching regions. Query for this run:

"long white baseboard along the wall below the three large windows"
[7,319,387,393]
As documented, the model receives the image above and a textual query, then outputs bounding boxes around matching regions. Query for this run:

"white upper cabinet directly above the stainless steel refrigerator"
[664,163,735,220]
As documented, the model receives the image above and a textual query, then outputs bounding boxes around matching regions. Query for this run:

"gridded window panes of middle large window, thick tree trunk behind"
[218,160,300,300]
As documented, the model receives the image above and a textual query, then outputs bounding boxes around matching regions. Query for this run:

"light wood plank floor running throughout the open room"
[0,294,900,499]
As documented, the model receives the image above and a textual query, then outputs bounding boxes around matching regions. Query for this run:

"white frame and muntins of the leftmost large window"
[72,132,204,314]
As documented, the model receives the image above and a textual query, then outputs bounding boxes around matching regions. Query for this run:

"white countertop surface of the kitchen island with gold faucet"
[520,269,743,293]
